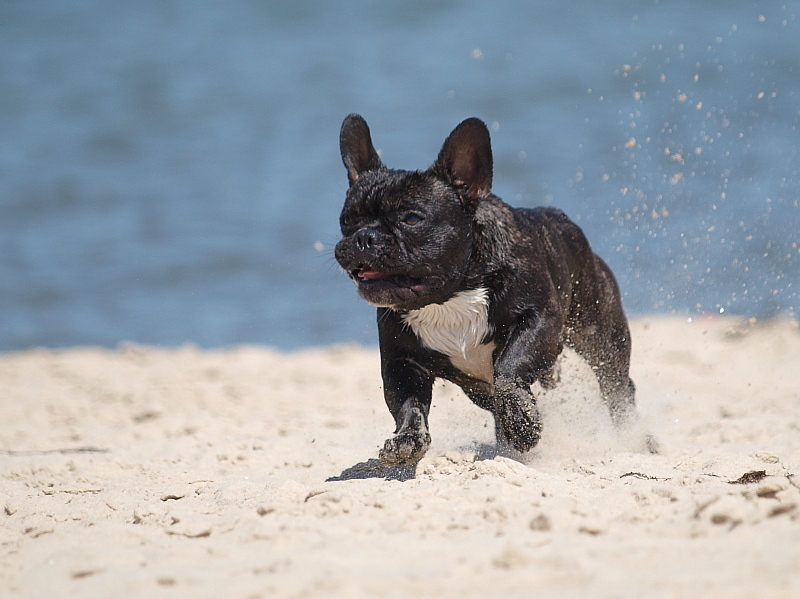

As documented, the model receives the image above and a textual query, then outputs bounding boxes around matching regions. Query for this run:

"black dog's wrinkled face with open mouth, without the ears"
[335,170,472,310]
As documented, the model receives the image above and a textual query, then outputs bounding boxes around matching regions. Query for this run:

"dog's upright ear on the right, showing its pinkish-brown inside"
[431,118,492,201]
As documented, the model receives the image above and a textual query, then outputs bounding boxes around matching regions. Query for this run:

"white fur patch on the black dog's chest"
[403,288,495,384]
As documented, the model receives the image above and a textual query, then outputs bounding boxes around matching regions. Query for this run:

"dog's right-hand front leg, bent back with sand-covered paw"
[493,316,563,452]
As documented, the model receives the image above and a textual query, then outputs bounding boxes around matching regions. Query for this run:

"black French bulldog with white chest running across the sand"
[335,114,634,465]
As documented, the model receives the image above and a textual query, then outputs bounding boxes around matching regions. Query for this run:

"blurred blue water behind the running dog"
[0,0,800,351]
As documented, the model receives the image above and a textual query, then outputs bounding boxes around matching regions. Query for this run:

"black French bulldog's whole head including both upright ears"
[335,114,492,310]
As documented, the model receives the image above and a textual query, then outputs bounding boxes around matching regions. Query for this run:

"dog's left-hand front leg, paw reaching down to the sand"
[378,358,433,466]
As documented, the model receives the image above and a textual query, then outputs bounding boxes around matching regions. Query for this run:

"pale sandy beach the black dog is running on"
[0,317,800,599]
